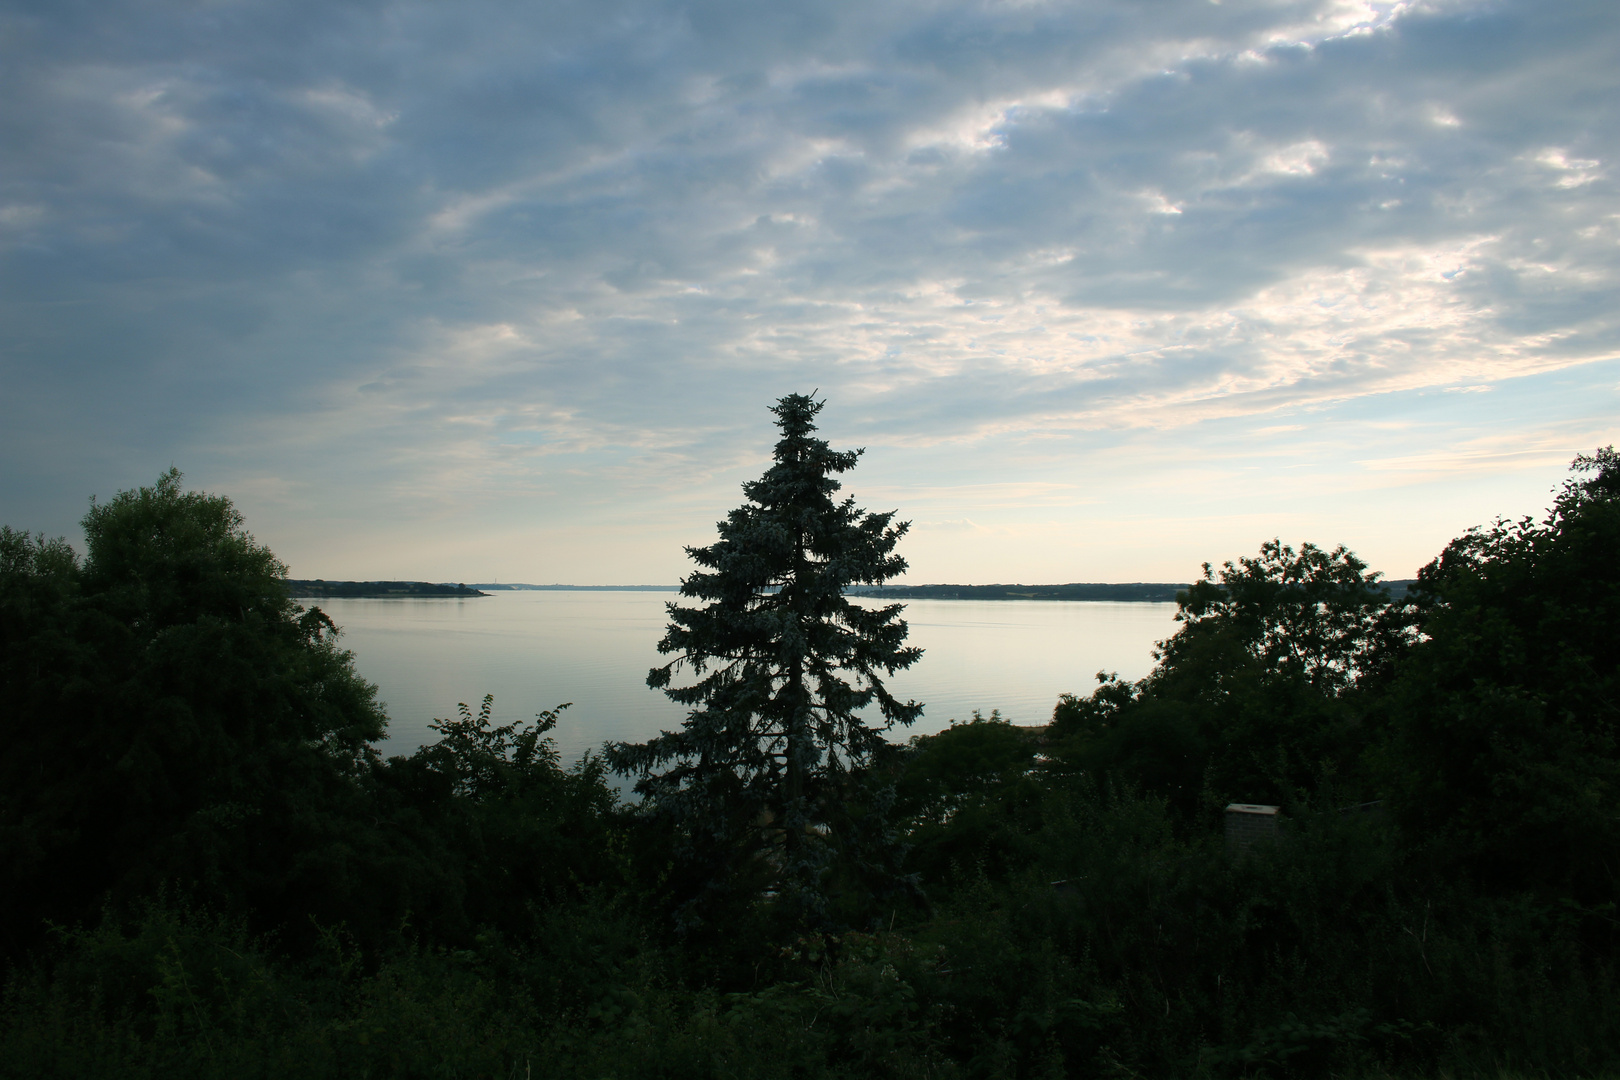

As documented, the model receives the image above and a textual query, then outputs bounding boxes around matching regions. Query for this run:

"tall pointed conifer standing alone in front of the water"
[609,393,922,926]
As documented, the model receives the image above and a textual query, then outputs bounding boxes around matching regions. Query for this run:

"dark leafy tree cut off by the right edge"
[1387,447,1620,902]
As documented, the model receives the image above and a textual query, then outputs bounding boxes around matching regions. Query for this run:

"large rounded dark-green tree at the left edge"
[0,470,386,944]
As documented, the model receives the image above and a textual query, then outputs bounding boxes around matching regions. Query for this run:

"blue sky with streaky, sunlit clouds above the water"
[0,0,1620,585]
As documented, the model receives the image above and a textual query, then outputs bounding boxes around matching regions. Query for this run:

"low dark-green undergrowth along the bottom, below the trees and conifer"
[12,785,1620,1078]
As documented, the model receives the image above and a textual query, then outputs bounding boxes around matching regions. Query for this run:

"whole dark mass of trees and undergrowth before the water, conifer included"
[0,427,1620,1078]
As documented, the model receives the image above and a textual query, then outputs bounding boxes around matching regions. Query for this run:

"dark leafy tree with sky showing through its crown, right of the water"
[1053,541,1409,810]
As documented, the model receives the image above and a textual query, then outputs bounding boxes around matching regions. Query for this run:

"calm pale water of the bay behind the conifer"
[319,593,1176,761]
